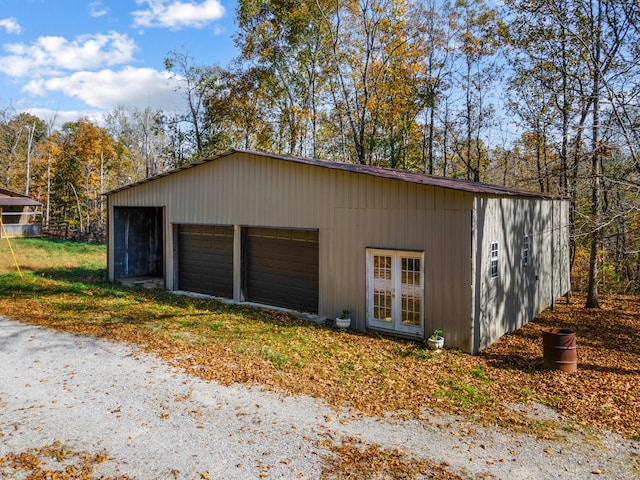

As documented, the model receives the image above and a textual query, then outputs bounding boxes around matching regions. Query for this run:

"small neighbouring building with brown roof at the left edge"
[0,188,42,238]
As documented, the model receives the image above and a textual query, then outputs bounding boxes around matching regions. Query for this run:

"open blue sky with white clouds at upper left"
[0,0,237,123]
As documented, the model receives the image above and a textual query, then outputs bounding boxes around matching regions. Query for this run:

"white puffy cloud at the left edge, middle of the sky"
[0,32,136,78]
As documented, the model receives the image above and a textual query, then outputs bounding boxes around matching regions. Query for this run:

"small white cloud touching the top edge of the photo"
[132,0,224,30]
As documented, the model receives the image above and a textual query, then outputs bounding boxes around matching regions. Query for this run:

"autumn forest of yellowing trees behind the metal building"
[0,0,640,307]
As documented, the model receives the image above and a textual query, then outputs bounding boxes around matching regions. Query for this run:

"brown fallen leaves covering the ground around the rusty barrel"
[479,295,640,440]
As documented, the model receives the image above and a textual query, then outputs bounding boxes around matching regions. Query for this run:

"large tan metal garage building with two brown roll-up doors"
[106,150,570,353]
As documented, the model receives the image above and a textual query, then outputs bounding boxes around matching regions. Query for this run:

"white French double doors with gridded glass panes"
[367,248,424,337]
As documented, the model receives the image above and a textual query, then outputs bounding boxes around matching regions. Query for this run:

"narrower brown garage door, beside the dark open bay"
[178,225,233,298]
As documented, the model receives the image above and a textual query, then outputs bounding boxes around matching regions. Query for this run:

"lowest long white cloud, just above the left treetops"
[24,67,184,111]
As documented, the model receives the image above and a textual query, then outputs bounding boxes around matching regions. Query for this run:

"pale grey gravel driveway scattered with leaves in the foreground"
[0,317,640,480]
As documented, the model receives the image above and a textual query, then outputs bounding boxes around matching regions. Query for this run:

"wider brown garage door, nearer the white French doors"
[243,228,318,313]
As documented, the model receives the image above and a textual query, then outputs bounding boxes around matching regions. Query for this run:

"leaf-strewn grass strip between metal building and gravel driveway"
[0,239,640,438]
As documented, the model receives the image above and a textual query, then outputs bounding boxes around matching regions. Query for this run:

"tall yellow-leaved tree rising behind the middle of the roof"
[317,0,419,164]
